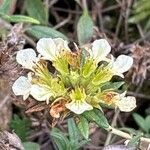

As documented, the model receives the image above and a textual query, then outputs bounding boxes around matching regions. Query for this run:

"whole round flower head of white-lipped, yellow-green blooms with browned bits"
[12,38,136,118]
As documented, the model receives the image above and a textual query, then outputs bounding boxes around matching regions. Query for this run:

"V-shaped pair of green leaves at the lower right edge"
[133,113,150,134]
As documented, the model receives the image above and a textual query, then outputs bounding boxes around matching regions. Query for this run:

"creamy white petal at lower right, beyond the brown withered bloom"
[117,96,136,112]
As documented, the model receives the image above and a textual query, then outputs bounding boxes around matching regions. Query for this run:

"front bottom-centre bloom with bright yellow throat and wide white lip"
[65,88,93,114]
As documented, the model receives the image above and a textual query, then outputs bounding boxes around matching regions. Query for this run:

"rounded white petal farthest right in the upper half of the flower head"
[113,55,133,74]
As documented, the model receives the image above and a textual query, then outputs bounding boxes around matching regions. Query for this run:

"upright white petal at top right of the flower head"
[89,39,111,64]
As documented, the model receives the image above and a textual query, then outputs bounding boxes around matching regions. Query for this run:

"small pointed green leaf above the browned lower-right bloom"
[101,81,124,91]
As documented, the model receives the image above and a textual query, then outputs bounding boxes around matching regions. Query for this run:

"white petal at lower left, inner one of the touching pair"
[30,84,53,102]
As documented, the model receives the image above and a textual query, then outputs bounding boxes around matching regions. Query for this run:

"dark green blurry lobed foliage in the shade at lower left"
[10,114,30,141]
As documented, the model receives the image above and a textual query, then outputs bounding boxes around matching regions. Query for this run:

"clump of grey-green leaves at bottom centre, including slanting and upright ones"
[50,118,88,150]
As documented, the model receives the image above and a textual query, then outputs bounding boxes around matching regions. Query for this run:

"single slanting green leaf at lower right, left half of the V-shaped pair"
[133,113,148,132]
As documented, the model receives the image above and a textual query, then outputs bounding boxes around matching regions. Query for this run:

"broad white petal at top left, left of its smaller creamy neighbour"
[37,38,57,61]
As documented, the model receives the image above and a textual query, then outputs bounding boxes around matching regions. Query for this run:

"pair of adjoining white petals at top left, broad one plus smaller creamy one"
[37,38,69,61]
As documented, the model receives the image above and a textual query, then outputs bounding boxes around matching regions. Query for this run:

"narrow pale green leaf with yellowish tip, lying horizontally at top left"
[0,13,40,24]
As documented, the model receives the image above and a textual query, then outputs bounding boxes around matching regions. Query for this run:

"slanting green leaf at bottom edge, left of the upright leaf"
[50,128,70,150]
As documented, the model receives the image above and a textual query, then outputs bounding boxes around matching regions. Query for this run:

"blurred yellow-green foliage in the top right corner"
[129,0,150,29]
